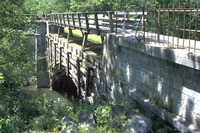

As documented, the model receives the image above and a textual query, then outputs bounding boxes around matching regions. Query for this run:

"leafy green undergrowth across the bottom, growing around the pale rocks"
[0,88,178,133]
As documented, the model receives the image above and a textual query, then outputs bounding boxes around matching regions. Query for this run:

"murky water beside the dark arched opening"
[22,85,71,104]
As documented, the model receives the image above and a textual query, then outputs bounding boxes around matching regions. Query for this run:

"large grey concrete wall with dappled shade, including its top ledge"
[96,34,200,130]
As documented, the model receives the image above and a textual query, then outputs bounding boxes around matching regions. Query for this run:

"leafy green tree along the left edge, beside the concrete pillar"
[0,0,34,88]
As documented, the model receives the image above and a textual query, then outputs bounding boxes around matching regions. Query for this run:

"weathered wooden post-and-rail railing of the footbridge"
[50,11,147,35]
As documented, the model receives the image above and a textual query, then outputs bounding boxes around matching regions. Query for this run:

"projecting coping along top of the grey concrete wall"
[106,34,200,70]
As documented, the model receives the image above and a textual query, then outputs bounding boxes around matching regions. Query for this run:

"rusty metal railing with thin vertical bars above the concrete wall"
[146,4,200,52]
